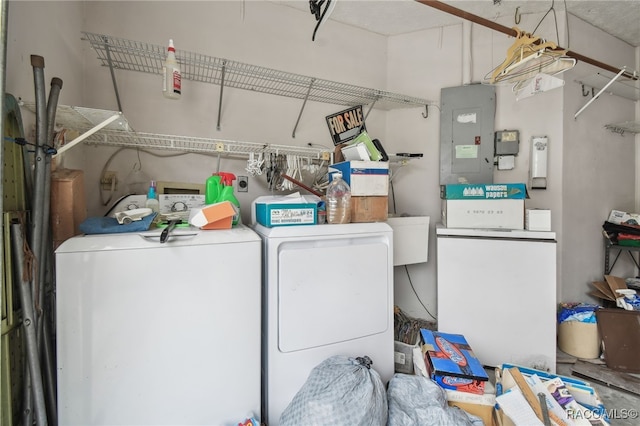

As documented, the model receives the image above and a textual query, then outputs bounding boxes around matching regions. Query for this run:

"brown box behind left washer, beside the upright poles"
[51,169,87,248]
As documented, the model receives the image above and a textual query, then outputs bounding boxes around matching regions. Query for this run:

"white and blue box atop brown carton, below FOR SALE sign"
[329,161,389,197]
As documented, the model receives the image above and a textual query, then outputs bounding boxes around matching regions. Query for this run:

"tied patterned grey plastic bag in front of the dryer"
[280,355,387,426]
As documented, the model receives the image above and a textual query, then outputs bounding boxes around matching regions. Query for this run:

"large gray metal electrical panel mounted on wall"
[440,84,496,185]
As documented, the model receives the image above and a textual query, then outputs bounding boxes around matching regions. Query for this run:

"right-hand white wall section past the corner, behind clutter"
[560,15,638,300]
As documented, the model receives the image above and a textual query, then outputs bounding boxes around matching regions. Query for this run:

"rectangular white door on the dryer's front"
[278,235,393,352]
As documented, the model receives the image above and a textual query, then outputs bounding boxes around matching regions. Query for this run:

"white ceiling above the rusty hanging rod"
[274,0,640,47]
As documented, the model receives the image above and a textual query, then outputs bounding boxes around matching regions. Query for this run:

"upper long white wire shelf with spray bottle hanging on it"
[83,31,433,110]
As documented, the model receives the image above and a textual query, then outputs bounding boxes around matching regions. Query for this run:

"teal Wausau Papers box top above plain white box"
[440,183,527,200]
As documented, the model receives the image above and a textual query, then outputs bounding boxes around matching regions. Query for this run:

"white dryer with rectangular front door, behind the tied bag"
[254,223,394,426]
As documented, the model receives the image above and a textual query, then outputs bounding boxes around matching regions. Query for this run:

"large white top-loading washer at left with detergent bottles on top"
[56,226,262,426]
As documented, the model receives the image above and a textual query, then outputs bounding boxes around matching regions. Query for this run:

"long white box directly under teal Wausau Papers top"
[442,199,524,229]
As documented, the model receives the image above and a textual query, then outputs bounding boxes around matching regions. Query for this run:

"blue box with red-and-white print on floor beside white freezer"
[420,329,489,395]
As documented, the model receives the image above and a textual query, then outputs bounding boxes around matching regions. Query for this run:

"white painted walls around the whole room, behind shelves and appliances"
[7,1,636,318]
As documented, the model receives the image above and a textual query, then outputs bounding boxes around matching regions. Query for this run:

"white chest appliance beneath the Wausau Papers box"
[436,226,556,372]
